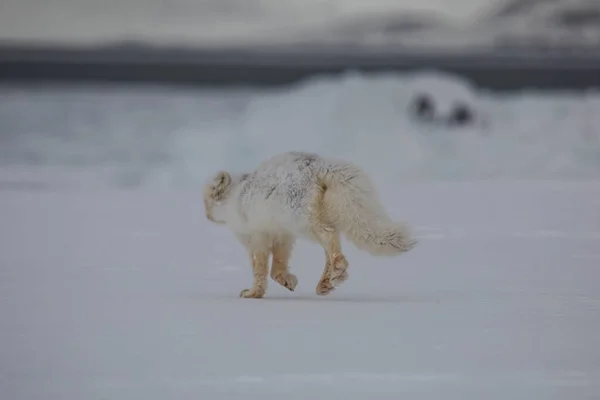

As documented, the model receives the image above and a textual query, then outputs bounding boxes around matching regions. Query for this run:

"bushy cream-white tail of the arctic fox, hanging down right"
[321,162,417,256]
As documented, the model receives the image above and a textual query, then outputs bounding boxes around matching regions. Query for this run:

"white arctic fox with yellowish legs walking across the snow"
[204,152,416,298]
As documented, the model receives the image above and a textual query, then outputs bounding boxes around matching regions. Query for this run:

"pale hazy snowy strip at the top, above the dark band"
[0,0,600,51]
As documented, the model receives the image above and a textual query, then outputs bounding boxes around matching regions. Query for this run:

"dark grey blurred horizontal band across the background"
[0,43,600,91]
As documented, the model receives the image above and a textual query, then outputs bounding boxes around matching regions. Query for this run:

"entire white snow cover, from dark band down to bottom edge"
[0,70,600,400]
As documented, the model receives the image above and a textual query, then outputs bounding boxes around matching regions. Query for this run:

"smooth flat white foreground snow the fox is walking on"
[0,182,600,400]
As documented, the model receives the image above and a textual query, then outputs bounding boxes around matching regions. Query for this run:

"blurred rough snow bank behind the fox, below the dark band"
[0,73,600,187]
